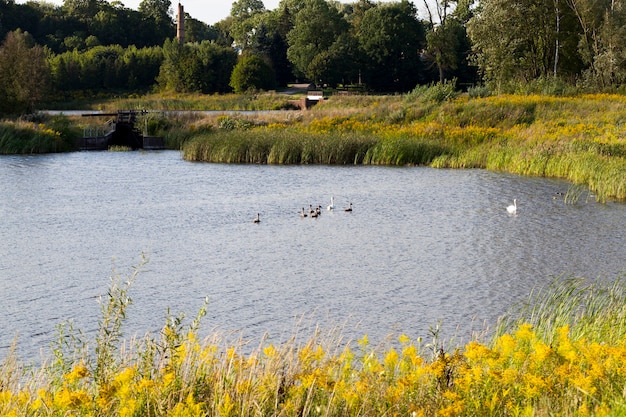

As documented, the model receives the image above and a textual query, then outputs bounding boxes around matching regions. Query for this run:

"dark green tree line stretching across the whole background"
[0,0,626,113]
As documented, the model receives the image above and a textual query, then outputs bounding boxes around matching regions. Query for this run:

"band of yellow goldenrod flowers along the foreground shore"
[0,324,626,416]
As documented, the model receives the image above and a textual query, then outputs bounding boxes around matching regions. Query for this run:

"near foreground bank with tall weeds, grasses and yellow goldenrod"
[0,256,626,416]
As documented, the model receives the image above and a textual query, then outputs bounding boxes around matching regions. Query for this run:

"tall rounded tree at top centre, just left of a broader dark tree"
[287,0,349,83]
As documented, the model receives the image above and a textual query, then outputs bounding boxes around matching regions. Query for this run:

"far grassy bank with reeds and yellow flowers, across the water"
[177,95,626,200]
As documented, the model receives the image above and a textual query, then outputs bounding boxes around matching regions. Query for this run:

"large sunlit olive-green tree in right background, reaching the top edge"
[467,0,581,91]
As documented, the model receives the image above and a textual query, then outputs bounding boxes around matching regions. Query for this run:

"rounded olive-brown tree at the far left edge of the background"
[0,30,49,114]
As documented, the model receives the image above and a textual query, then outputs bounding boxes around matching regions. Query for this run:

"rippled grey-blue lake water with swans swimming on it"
[0,151,626,359]
